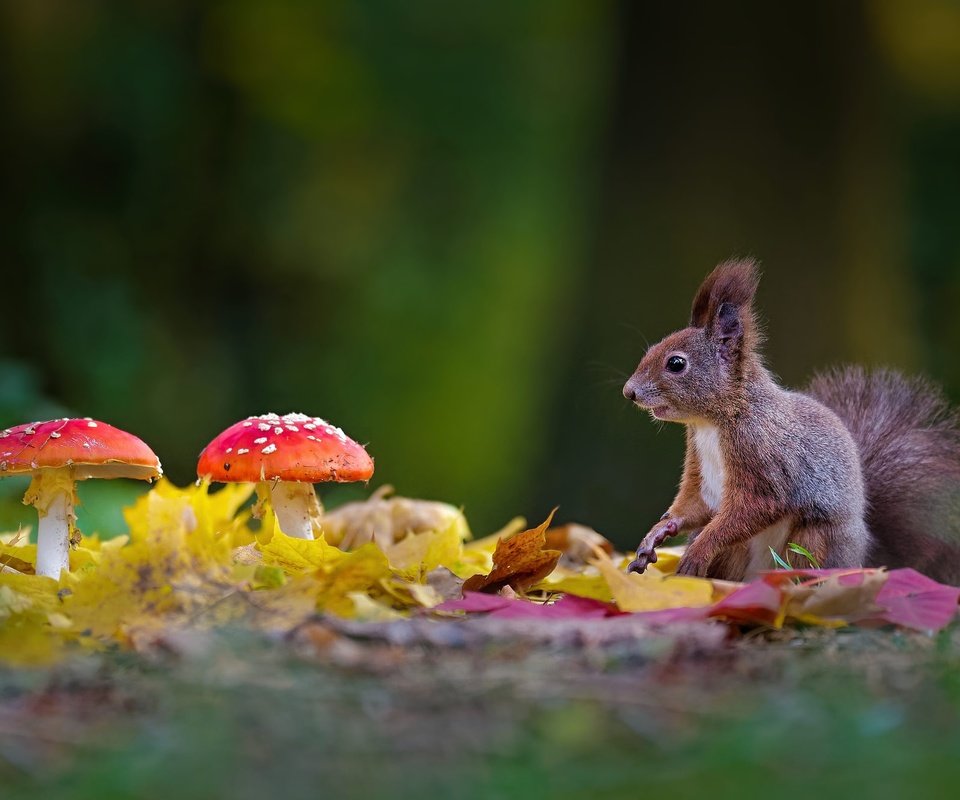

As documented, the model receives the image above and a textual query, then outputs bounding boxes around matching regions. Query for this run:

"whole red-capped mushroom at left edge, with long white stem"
[0,417,163,578]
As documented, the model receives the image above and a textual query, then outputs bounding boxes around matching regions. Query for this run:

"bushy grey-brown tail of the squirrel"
[807,367,960,584]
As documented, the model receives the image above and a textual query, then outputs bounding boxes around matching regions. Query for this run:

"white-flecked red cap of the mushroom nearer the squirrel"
[197,414,373,483]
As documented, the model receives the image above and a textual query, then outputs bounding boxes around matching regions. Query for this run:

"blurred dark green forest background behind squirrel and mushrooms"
[0,0,960,546]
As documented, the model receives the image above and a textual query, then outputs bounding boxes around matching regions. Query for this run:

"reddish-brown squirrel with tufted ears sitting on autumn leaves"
[623,259,960,584]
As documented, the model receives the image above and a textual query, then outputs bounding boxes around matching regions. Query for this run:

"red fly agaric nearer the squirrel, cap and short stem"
[197,414,373,539]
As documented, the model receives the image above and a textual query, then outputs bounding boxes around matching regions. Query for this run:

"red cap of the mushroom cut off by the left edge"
[0,417,163,481]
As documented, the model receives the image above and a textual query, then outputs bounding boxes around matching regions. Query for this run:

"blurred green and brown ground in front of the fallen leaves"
[0,617,960,800]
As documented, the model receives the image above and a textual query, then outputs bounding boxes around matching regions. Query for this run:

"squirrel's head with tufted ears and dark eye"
[623,259,759,422]
